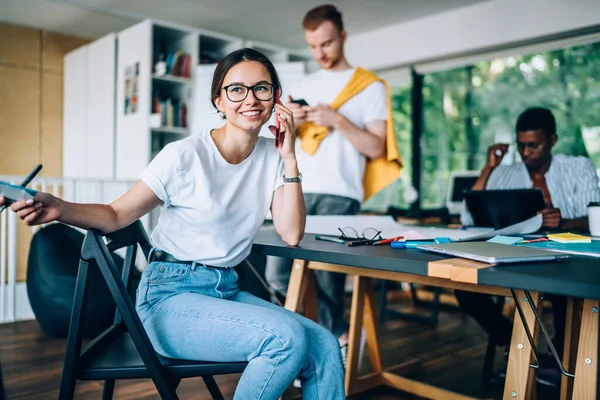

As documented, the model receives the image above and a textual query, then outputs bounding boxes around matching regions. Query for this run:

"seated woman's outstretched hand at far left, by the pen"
[0,192,60,226]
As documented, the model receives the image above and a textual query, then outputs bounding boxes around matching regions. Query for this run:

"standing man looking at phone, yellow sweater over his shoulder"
[266,5,392,356]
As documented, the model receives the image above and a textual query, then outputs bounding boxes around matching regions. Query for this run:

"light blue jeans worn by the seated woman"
[136,262,345,400]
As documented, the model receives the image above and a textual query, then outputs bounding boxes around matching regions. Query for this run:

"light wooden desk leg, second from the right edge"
[503,290,542,400]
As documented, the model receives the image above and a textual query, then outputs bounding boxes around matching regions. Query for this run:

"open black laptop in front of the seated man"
[464,189,546,229]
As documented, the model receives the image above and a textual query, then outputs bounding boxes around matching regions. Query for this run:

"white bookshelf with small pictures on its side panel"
[116,20,199,179]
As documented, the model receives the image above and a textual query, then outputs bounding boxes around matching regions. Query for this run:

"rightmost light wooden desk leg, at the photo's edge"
[573,300,600,400]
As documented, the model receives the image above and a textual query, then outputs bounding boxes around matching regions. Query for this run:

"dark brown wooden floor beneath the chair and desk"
[0,292,551,400]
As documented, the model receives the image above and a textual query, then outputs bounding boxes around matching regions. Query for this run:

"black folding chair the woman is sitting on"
[59,221,247,400]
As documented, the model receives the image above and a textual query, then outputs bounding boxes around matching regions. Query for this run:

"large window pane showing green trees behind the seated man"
[418,43,600,209]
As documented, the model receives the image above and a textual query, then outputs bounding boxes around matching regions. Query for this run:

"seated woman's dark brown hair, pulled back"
[210,47,281,108]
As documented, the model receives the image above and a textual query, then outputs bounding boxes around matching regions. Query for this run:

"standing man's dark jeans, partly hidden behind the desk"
[265,193,360,337]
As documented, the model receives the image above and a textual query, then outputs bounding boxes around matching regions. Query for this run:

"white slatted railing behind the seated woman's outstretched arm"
[0,176,137,323]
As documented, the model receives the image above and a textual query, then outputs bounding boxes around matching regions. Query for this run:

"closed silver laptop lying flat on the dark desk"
[417,242,571,264]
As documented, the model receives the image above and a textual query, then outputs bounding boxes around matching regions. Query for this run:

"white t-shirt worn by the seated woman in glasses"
[140,131,283,267]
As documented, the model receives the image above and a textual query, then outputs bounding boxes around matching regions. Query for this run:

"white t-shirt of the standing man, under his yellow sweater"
[290,68,388,202]
